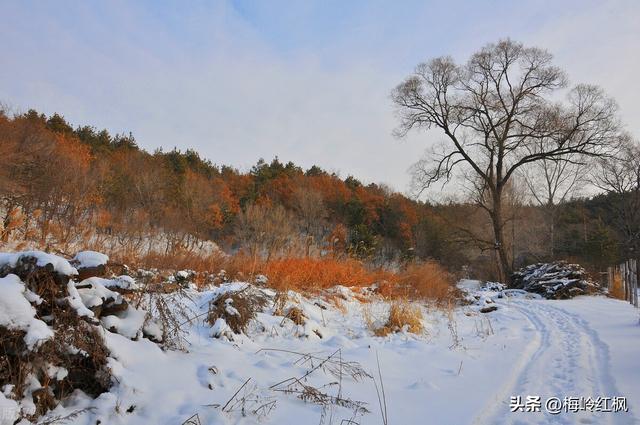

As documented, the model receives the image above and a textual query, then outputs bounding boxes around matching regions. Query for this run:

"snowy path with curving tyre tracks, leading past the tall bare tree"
[474,299,638,425]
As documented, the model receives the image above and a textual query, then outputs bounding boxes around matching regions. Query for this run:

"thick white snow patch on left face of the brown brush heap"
[0,274,53,350]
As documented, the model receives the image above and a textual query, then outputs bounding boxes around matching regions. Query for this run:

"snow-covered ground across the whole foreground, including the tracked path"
[0,256,640,425]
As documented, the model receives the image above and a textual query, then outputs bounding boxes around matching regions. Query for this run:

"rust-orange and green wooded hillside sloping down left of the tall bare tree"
[0,110,460,263]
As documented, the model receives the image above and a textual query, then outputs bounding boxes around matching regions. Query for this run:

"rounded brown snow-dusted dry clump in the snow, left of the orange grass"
[207,287,267,334]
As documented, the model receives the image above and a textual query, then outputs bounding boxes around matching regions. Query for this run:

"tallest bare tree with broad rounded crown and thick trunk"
[392,40,620,281]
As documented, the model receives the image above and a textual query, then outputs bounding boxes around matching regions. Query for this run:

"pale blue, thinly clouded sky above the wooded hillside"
[0,0,640,191]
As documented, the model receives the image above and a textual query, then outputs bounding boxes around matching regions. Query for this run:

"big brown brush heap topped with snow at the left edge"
[0,252,111,419]
